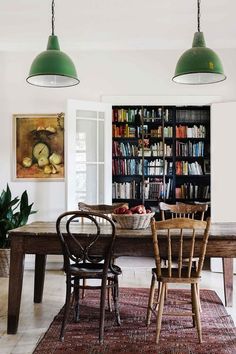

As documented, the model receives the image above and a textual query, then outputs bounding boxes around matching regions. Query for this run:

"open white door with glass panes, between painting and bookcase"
[65,100,112,210]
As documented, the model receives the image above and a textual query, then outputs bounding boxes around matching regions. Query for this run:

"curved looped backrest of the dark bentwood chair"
[56,210,116,272]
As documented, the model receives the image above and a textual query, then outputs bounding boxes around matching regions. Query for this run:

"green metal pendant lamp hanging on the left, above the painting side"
[26,0,80,88]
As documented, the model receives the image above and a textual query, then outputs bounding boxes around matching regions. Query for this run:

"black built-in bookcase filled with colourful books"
[112,106,210,213]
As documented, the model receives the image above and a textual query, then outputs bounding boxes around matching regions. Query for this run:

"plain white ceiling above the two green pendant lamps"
[0,0,236,51]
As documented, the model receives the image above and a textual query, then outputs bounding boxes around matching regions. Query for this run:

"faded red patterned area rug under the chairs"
[34,288,236,354]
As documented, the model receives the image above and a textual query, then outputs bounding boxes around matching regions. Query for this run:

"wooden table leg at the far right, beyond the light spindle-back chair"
[222,258,234,307]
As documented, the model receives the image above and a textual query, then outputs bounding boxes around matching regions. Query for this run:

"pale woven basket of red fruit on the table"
[112,205,155,230]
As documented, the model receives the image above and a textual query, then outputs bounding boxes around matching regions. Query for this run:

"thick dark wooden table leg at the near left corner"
[7,242,25,334]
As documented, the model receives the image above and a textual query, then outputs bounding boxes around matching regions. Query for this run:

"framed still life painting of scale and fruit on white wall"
[13,113,64,181]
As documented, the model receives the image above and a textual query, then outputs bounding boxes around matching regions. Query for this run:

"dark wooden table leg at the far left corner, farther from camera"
[34,254,47,303]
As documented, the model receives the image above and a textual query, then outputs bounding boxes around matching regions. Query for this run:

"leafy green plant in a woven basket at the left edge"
[0,184,36,276]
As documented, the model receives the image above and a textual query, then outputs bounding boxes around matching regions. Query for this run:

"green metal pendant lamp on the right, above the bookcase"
[172,0,226,85]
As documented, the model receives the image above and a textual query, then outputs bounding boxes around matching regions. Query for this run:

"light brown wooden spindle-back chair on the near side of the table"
[147,218,210,343]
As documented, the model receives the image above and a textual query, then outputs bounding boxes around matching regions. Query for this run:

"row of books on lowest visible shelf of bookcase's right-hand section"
[175,183,211,199]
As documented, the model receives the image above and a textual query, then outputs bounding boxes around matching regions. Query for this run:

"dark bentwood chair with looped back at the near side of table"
[56,211,121,343]
